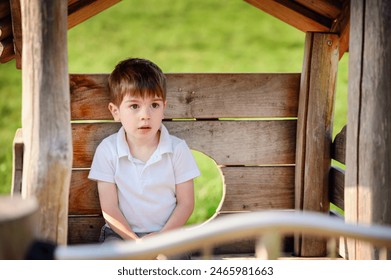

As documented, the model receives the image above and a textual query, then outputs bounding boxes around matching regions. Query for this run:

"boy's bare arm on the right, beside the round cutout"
[155,179,194,232]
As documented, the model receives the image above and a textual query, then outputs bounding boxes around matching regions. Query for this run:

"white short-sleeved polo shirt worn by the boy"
[88,125,200,233]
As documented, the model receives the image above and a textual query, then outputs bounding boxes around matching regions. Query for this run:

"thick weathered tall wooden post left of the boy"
[21,0,72,244]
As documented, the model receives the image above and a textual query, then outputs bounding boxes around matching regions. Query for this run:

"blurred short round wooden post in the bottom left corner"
[0,196,38,260]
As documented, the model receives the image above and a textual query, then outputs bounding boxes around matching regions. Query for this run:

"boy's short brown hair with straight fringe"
[109,58,167,106]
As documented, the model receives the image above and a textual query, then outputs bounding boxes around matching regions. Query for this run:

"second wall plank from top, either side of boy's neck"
[72,120,296,168]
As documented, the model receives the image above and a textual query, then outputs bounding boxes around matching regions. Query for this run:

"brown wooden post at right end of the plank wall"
[295,32,339,257]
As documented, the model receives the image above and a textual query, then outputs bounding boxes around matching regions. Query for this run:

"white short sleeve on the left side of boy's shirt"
[88,140,115,183]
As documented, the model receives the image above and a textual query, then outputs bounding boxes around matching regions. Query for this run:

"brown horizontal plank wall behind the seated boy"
[68,74,300,243]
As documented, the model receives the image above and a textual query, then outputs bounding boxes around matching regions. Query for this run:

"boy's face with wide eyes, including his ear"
[109,95,166,143]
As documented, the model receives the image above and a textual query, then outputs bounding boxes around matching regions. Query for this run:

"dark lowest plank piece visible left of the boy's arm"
[68,215,105,245]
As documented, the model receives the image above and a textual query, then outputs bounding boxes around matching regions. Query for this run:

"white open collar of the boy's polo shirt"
[117,124,173,160]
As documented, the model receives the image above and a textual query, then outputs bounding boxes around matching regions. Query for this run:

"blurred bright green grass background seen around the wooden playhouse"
[0,0,348,222]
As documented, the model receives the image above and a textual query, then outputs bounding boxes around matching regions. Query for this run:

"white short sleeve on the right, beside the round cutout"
[173,140,201,184]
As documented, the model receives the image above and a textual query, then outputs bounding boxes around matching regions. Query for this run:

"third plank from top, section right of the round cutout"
[220,166,295,211]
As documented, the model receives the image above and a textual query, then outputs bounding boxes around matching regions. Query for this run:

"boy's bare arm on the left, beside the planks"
[98,181,139,240]
